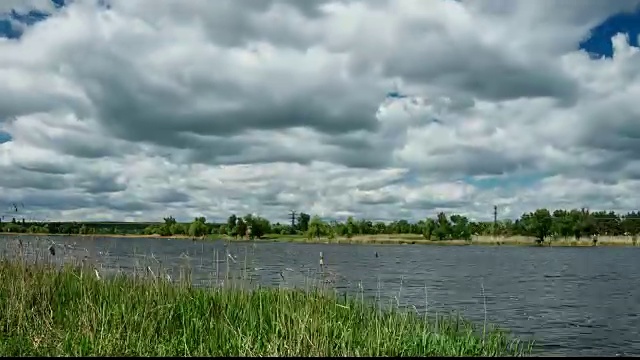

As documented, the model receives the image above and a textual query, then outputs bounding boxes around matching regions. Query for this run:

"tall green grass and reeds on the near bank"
[0,260,531,356]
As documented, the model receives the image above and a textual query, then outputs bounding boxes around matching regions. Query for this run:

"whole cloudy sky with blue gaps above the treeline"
[0,0,640,225]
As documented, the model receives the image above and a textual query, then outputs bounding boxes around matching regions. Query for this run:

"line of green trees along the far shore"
[0,209,640,245]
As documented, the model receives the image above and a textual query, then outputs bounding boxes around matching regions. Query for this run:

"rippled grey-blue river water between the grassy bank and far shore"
[0,237,640,356]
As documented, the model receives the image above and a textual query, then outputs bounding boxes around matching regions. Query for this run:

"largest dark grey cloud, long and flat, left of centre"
[71,56,377,156]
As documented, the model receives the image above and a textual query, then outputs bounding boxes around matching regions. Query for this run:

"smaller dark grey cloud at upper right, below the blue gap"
[385,43,578,104]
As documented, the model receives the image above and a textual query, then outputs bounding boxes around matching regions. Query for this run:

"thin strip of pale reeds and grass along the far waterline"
[0,232,640,247]
